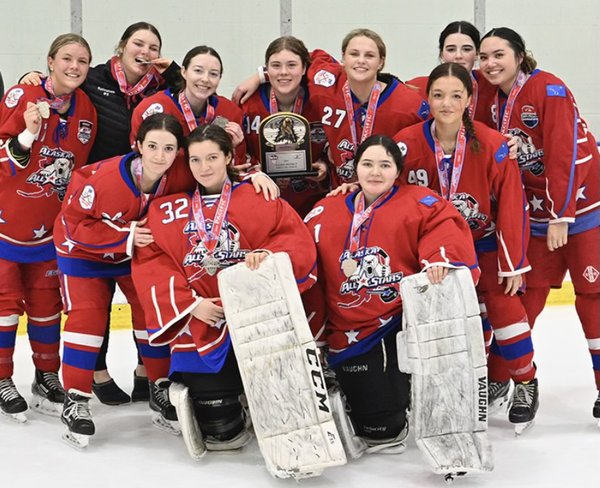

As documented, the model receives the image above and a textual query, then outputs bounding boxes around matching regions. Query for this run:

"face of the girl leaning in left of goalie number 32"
[137,129,178,182]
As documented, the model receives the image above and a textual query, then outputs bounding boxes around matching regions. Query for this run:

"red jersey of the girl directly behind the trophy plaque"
[242,83,329,217]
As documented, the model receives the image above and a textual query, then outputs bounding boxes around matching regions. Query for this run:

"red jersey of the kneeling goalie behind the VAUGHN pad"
[305,185,479,365]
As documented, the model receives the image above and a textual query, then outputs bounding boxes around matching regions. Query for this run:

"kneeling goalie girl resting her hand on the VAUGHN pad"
[305,135,479,453]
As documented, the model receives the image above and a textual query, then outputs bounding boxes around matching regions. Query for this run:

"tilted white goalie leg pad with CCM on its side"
[218,253,346,479]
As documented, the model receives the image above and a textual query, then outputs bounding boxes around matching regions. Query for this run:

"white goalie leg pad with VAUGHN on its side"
[398,268,494,474]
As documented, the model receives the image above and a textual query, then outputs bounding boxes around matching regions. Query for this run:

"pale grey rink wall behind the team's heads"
[0,0,600,136]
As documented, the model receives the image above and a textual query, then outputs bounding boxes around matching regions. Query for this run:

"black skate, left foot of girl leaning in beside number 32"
[60,390,96,449]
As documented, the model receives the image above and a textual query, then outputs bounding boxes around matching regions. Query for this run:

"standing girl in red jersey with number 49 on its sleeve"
[394,63,538,430]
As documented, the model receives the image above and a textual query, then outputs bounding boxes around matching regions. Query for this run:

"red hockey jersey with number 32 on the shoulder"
[132,183,316,372]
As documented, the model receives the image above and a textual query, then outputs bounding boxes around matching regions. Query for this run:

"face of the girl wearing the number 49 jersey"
[429,76,471,126]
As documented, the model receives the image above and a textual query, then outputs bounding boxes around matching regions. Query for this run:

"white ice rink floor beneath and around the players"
[0,306,600,488]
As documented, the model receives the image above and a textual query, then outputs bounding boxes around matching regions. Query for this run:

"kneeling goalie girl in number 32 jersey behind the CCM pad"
[132,124,316,450]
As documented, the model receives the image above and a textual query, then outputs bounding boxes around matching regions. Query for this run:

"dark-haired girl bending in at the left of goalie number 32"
[54,114,183,447]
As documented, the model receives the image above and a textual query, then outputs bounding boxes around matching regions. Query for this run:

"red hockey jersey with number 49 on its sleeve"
[394,120,530,276]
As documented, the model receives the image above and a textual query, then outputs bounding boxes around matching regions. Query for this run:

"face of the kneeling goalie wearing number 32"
[188,140,232,195]
